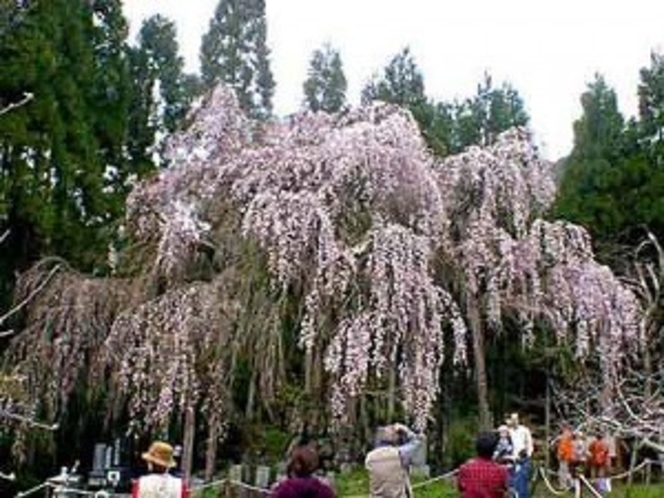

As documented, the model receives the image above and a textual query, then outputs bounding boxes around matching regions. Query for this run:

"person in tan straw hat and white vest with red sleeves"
[131,441,189,498]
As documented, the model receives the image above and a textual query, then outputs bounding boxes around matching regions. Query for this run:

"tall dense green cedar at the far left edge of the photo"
[0,0,121,282]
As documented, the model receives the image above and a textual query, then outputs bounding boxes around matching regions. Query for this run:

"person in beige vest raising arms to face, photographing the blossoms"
[364,424,423,498]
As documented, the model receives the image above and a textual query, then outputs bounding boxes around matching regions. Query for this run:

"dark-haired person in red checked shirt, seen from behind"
[457,432,509,498]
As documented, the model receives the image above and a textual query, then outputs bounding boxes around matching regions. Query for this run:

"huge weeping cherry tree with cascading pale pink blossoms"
[3,82,641,472]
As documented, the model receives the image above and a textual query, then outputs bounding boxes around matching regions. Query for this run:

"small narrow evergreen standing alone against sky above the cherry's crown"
[303,45,348,112]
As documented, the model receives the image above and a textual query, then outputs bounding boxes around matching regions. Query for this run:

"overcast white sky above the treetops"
[125,0,664,159]
